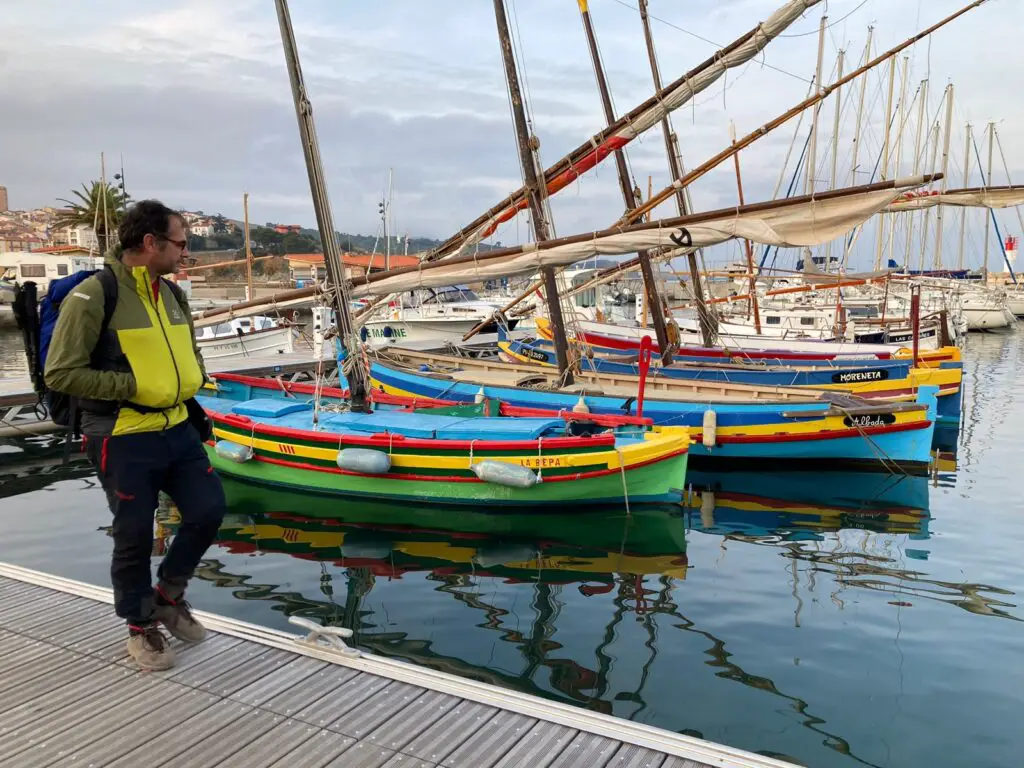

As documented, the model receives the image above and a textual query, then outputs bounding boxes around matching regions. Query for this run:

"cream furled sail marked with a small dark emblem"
[352,176,934,297]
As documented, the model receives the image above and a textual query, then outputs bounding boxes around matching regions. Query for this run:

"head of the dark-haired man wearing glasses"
[118,200,188,275]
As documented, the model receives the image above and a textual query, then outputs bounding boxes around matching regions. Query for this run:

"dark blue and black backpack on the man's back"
[13,266,118,432]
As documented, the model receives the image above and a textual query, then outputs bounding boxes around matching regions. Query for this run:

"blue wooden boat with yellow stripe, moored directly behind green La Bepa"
[371,349,937,473]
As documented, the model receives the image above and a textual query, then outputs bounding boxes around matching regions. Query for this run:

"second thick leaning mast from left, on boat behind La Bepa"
[491,0,572,386]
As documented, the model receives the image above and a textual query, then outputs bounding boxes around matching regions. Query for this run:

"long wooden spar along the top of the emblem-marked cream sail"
[346,174,939,290]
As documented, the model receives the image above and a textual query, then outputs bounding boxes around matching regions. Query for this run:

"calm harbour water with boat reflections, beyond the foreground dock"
[0,332,1024,768]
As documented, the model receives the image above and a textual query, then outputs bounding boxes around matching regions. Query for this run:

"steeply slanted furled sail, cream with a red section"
[426,0,820,260]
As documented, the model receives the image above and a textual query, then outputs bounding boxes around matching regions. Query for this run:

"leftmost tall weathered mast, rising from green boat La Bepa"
[275,0,368,411]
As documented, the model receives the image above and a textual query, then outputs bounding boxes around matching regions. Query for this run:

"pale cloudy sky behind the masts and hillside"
[0,0,1024,268]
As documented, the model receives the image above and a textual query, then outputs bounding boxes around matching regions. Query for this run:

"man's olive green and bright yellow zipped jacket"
[45,255,206,437]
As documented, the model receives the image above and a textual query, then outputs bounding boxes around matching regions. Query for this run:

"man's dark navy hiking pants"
[86,421,224,625]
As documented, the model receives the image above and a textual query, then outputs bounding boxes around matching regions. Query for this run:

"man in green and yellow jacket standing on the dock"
[45,200,224,670]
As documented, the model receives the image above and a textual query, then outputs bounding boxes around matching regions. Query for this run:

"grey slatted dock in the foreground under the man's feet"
[0,563,792,768]
